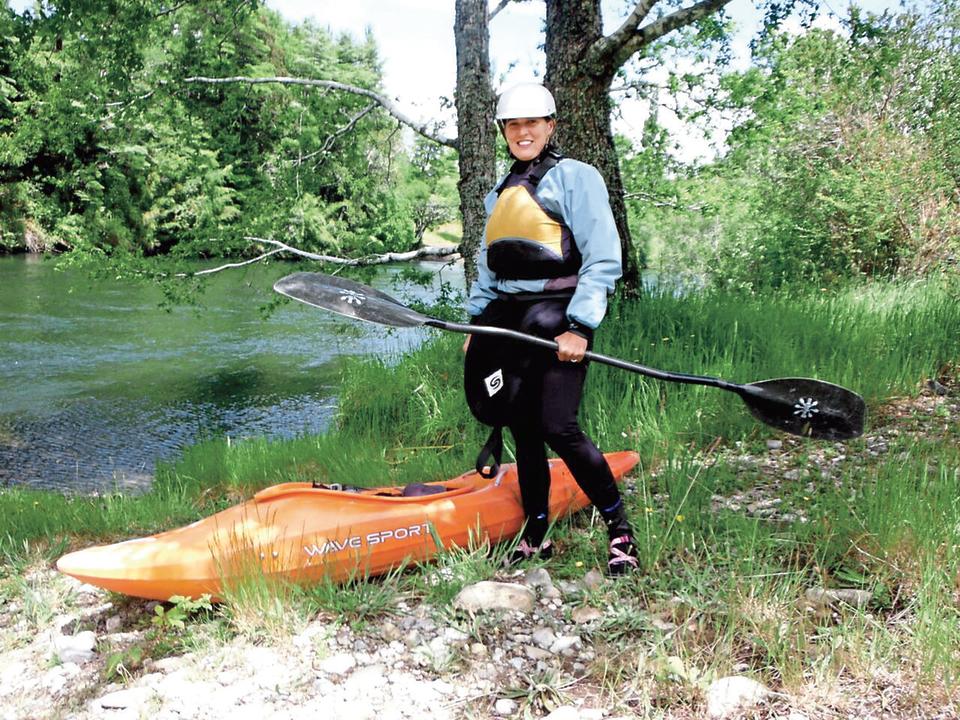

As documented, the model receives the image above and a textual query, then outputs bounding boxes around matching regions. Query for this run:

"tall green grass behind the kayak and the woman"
[0,281,960,552]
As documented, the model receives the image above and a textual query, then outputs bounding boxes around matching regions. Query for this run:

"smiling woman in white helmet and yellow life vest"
[464,83,637,575]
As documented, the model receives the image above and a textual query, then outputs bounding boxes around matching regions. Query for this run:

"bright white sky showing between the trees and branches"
[9,0,912,161]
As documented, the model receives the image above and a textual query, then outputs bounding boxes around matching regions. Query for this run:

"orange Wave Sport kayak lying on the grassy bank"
[57,452,639,600]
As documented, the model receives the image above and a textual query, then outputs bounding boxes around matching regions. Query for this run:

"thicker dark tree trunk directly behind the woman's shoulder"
[540,0,645,290]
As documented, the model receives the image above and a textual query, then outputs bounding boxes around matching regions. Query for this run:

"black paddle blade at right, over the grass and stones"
[740,378,867,440]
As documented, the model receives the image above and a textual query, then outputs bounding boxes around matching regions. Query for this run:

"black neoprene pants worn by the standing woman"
[485,299,630,546]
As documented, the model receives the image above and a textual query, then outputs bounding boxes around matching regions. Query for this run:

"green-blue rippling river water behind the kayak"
[0,255,462,492]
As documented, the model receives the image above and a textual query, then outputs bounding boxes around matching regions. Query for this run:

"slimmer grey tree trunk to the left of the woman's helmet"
[454,0,497,289]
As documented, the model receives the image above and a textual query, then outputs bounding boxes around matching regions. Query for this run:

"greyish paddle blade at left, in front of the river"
[273,272,430,327]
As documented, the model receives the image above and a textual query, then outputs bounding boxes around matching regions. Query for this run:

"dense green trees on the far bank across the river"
[0,0,455,266]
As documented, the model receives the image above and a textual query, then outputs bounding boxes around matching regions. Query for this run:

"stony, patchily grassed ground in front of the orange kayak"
[0,376,960,720]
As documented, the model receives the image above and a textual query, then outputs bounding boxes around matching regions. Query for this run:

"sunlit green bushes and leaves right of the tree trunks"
[627,0,960,289]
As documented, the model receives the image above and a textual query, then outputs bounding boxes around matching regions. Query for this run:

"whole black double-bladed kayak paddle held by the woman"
[273,272,866,440]
